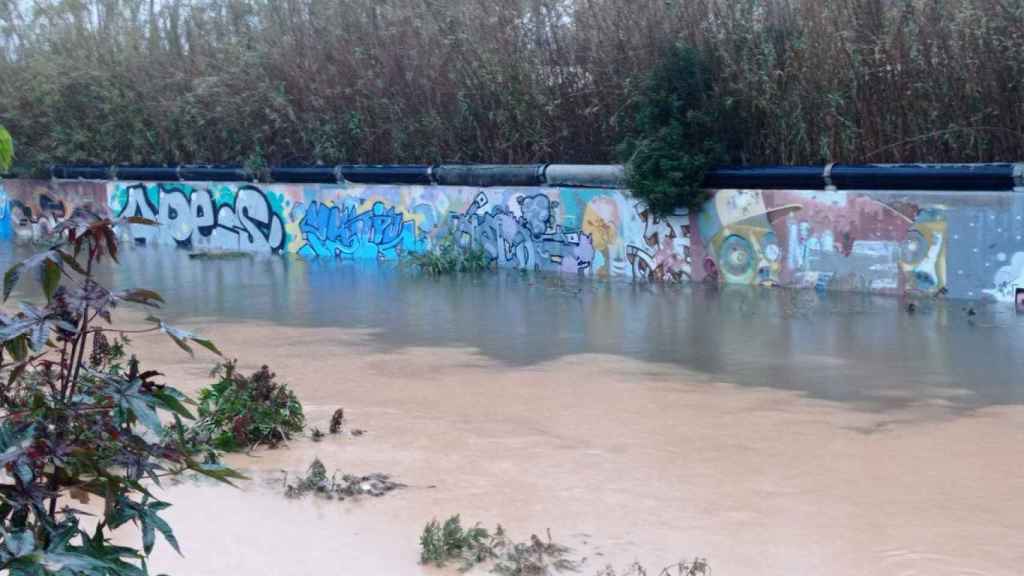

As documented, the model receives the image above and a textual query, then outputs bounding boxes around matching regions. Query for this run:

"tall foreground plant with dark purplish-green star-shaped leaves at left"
[0,213,242,576]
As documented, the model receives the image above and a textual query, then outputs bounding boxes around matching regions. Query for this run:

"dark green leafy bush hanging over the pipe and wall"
[618,45,726,214]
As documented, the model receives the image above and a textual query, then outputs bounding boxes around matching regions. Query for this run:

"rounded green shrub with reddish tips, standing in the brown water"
[190,362,305,451]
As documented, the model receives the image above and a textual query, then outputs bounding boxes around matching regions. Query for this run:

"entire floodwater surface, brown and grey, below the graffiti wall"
[6,243,1024,576]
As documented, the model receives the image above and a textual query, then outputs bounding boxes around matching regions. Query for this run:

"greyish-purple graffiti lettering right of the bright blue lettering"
[451,192,594,273]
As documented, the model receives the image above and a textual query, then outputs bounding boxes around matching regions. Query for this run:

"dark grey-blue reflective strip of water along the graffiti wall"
[0,245,1024,408]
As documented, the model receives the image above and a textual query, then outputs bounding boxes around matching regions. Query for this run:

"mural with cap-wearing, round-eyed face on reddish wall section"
[697,191,947,294]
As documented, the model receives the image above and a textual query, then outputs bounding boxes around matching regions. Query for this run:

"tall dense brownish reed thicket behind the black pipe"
[0,0,1024,165]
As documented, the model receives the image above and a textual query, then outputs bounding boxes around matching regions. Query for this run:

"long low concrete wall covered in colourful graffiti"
[0,178,1024,302]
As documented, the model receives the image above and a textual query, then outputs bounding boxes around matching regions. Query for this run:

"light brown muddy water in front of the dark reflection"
[112,321,1024,576]
